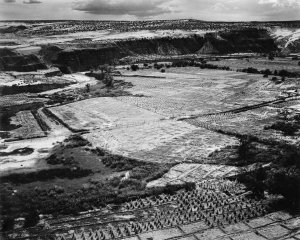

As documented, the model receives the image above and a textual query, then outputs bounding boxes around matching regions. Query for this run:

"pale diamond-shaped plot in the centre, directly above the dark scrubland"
[84,120,238,163]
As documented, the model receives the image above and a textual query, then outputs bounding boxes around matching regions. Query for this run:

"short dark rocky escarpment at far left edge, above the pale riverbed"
[0,48,47,72]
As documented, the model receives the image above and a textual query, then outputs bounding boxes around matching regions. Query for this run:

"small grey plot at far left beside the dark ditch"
[10,111,45,139]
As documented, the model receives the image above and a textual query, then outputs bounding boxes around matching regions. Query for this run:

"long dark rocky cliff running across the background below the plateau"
[44,29,277,73]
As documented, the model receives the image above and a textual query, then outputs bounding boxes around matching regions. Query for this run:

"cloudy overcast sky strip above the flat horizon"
[0,0,300,21]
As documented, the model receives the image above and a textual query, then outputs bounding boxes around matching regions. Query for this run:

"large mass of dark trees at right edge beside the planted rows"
[220,139,300,212]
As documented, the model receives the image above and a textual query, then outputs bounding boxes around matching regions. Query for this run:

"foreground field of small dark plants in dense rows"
[56,180,272,240]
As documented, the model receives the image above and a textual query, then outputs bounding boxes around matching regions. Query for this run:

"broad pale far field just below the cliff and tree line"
[118,67,288,117]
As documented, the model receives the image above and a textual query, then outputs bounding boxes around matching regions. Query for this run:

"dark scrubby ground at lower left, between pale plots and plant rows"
[0,135,175,230]
